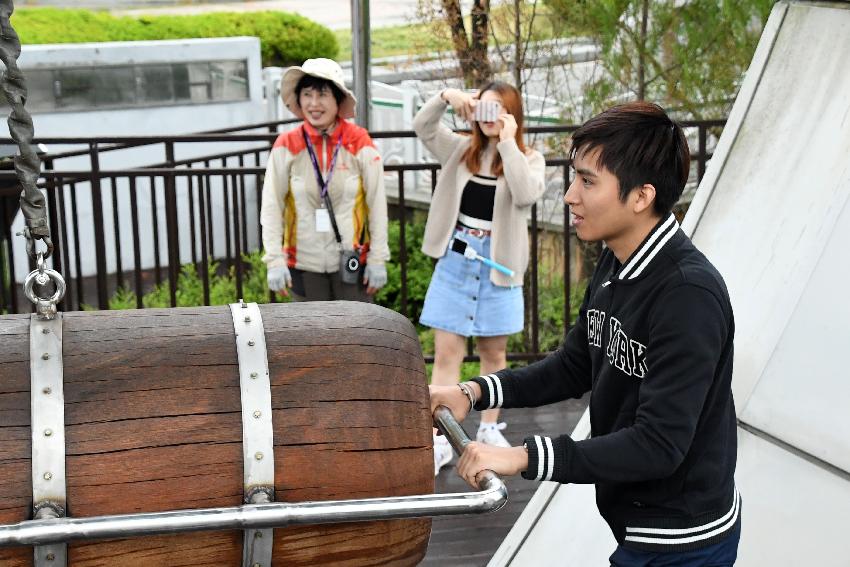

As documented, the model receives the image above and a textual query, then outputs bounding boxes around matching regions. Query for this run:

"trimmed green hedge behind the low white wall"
[12,8,339,66]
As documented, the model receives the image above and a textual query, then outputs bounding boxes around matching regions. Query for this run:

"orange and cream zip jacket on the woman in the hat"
[260,119,390,273]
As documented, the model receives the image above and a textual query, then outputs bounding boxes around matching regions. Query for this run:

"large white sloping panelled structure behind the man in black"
[490,2,850,567]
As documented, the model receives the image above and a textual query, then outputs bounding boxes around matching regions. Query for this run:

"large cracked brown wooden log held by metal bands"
[0,302,434,567]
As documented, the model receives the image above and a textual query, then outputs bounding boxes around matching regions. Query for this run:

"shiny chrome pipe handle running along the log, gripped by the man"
[0,406,508,547]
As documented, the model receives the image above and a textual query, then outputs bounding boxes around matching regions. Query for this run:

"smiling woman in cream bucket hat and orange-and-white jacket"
[260,58,390,301]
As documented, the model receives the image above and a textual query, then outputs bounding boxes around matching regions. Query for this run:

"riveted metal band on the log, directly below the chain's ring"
[30,313,68,567]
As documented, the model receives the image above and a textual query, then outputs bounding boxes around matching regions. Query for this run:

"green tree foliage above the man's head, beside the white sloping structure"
[547,0,775,120]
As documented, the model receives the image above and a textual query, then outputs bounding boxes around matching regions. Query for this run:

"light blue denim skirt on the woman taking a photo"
[419,231,524,337]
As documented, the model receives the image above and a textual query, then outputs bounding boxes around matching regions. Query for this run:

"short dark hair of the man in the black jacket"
[570,101,691,216]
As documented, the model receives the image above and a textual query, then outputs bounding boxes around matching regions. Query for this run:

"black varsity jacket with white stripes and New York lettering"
[474,214,741,551]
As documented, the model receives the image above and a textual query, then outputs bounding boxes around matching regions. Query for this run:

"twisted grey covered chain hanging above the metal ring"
[0,0,53,258]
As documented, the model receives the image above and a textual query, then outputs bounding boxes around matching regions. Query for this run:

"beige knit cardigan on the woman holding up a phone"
[413,94,546,287]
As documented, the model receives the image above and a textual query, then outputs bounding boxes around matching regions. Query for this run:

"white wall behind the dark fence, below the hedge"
[6,37,266,280]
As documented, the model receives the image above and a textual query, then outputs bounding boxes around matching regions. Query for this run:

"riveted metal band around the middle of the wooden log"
[230,300,274,567]
